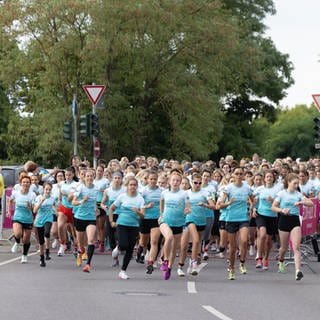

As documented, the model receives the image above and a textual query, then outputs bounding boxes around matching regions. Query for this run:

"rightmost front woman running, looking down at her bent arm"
[272,173,313,280]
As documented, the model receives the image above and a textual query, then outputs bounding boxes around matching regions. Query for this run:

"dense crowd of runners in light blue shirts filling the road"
[7,154,320,280]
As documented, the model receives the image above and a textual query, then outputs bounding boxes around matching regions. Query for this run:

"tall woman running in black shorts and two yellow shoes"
[221,167,254,280]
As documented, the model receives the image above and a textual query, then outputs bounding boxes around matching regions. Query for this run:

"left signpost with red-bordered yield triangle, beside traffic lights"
[83,84,106,168]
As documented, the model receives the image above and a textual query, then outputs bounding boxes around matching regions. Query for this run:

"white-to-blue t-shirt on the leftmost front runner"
[11,190,36,224]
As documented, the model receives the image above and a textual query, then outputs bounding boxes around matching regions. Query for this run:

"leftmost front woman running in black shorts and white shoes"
[7,175,36,263]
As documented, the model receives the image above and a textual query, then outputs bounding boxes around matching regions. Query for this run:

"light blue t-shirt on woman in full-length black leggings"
[113,193,144,227]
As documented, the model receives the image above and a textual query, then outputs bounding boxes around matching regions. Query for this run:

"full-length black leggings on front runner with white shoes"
[117,225,139,271]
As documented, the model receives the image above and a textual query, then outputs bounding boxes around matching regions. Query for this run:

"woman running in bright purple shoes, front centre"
[159,171,190,280]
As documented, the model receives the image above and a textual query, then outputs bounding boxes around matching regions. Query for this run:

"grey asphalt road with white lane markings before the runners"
[0,245,320,320]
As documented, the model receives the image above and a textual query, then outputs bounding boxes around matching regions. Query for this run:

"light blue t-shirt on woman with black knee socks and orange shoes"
[74,184,98,220]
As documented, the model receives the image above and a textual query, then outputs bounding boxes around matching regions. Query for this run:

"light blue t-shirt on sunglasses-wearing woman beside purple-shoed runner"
[186,190,209,226]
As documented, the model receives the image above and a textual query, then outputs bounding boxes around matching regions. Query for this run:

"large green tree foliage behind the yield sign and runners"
[0,0,292,165]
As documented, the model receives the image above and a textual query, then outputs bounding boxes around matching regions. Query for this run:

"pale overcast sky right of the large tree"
[265,0,320,108]
